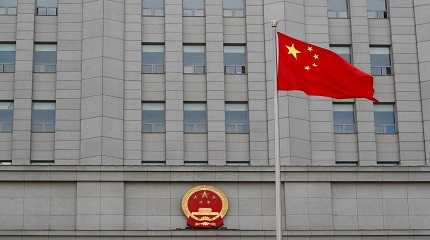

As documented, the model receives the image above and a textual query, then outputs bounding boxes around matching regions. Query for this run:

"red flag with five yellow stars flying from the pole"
[278,32,377,102]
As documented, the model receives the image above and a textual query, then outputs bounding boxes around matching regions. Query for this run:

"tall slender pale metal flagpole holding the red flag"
[272,20,282,240]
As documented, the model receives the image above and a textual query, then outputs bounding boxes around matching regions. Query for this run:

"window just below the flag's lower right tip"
[374,104,396,134]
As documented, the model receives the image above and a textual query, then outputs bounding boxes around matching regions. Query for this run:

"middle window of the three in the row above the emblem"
[184,103,208,133]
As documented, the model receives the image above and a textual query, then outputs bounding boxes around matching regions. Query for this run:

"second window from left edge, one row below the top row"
[34,44,57,72]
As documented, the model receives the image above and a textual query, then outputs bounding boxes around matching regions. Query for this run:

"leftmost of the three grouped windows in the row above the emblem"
[142,102,165,133]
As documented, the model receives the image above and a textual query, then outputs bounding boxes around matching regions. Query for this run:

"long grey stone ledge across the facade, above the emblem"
[0,165,430,182]
